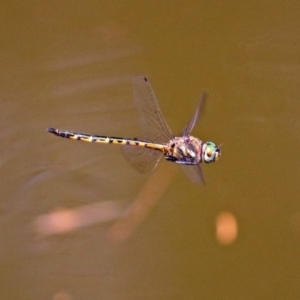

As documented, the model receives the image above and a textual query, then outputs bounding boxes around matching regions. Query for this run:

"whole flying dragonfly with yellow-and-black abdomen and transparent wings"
[47,75,221,184]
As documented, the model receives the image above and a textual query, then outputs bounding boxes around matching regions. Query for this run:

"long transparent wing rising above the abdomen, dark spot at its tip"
[133,75,173,143]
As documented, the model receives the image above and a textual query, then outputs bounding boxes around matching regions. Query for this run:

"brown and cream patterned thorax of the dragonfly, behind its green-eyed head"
[165,136,203,165]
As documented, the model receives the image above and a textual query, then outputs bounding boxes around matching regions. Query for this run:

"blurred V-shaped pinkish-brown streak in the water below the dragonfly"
[31,164,177,242]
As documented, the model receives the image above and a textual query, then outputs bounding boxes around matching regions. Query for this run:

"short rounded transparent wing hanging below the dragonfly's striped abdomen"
[121,145,162,173]
